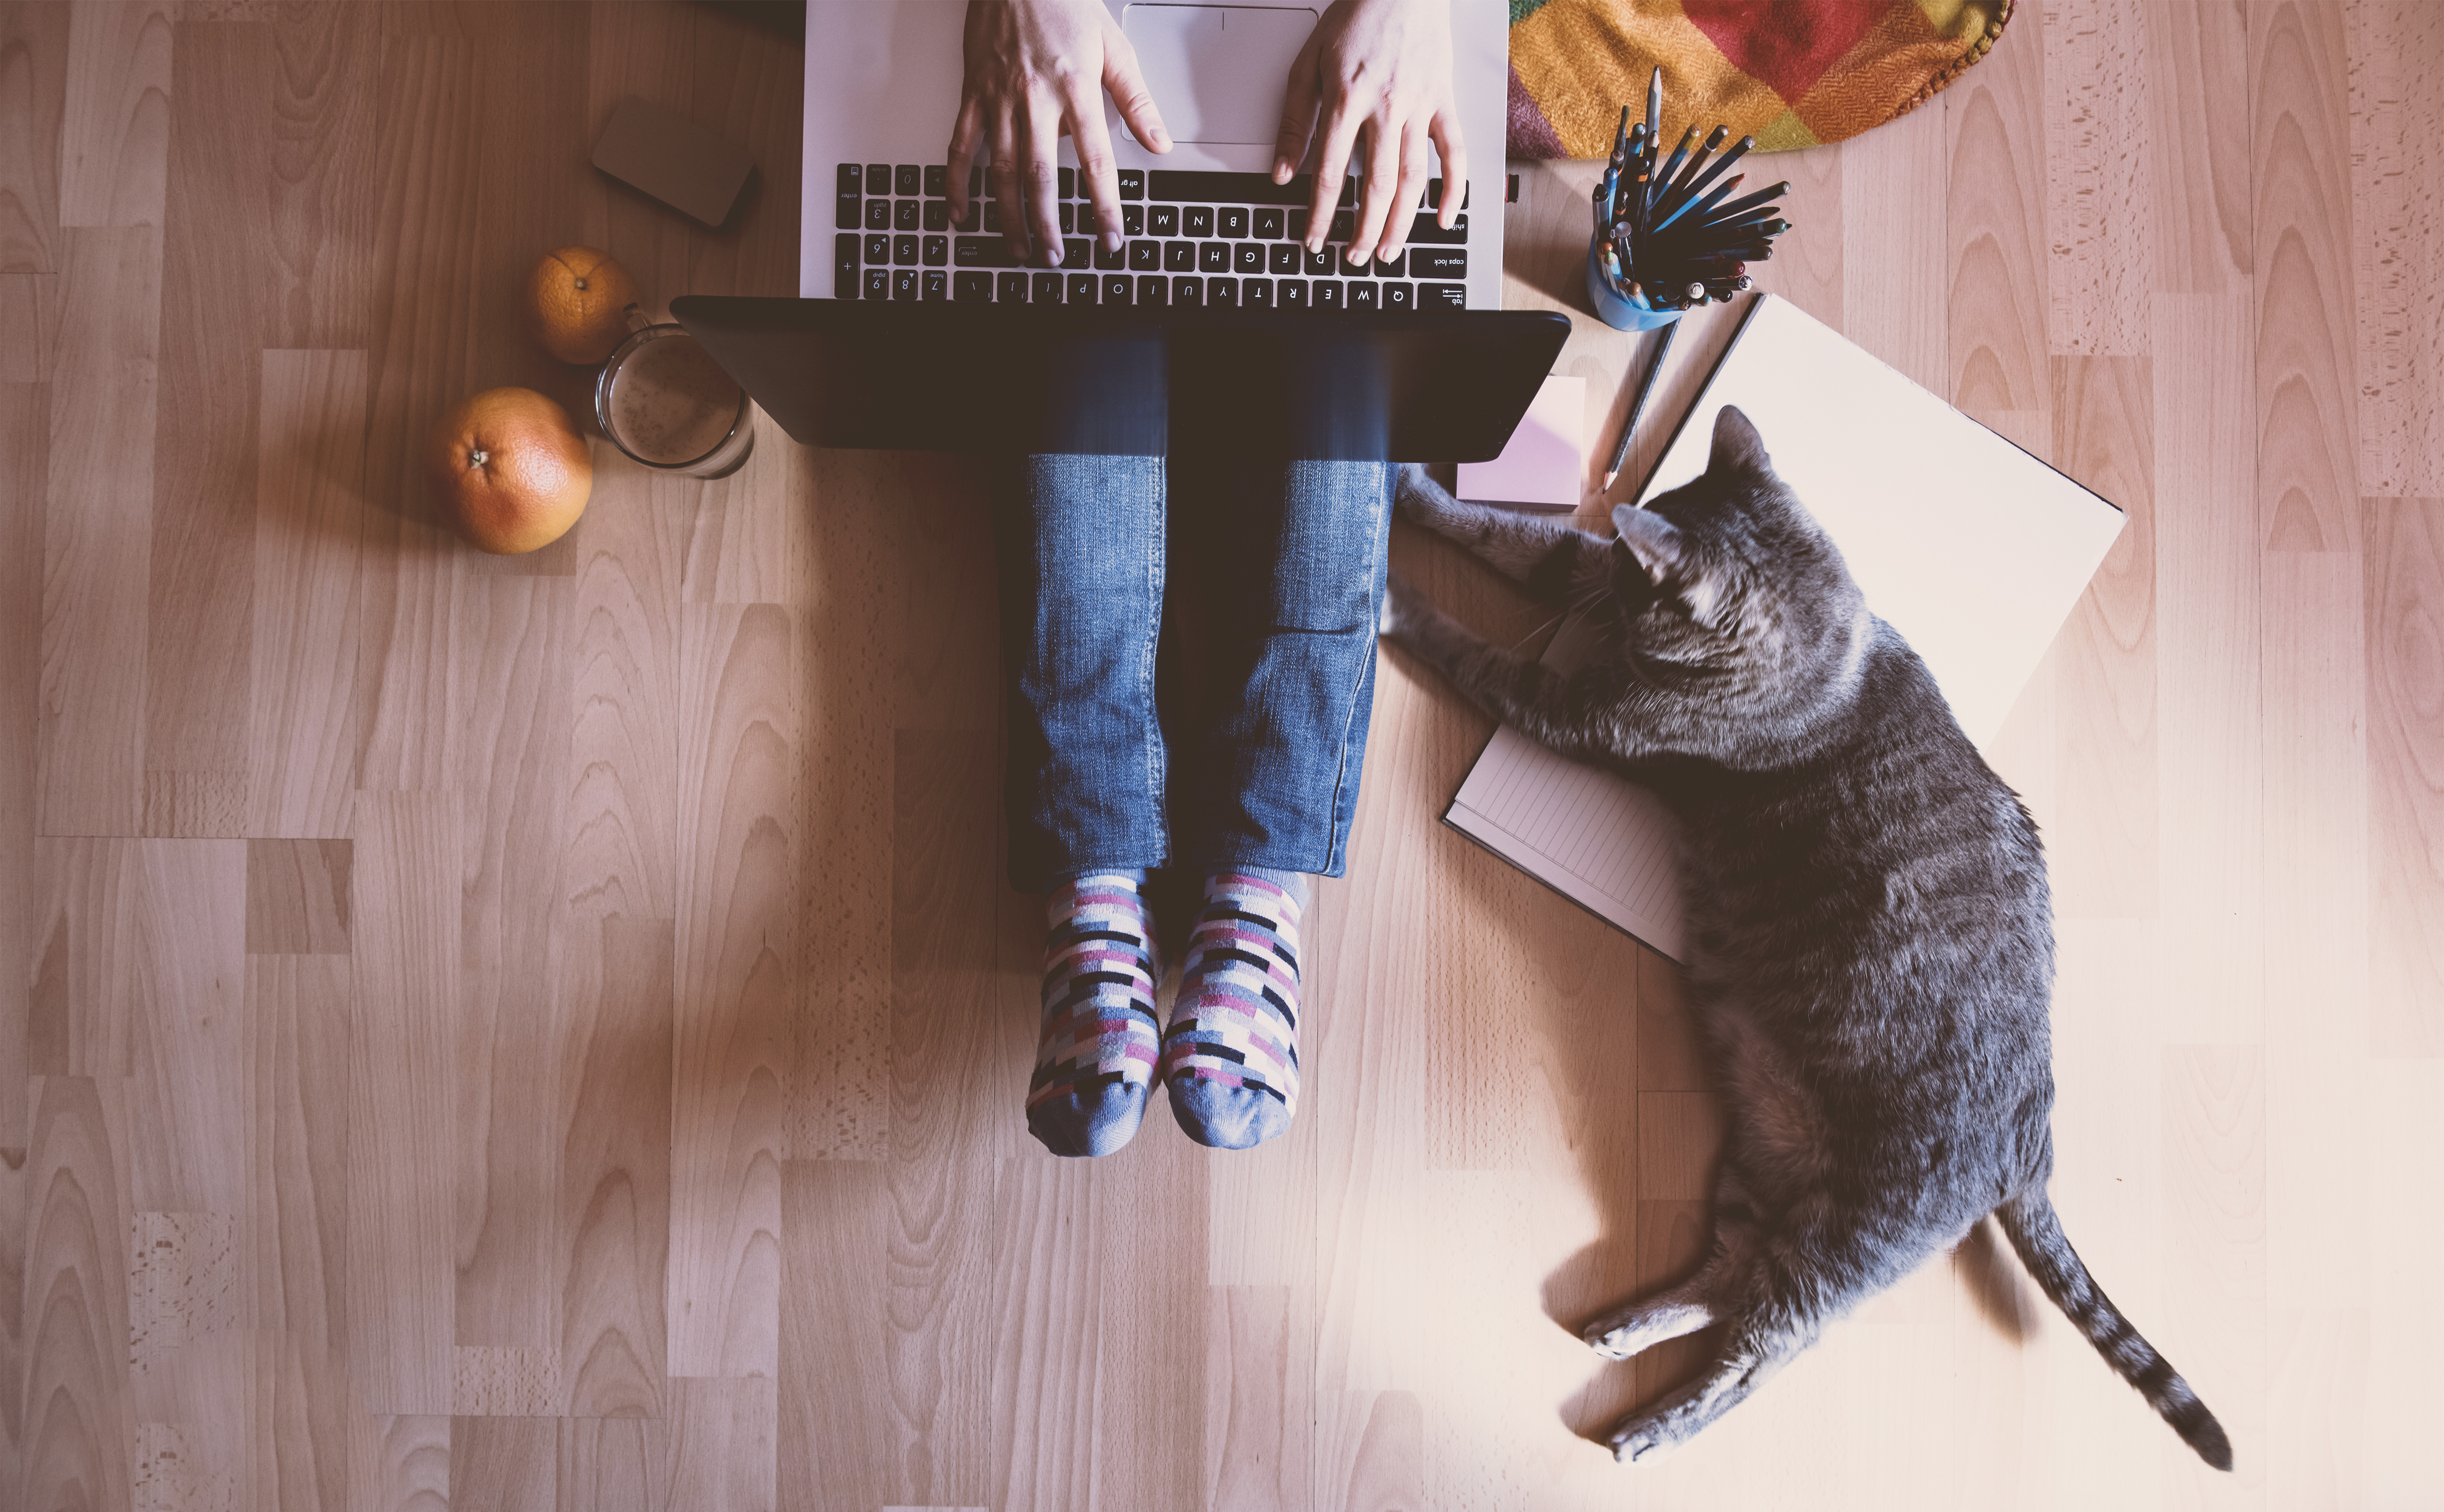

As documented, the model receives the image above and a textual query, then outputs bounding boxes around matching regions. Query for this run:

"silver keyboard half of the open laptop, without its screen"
[799,0,1510,315]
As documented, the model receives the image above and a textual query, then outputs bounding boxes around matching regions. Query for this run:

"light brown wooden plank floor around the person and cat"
[0,0,2444,1512]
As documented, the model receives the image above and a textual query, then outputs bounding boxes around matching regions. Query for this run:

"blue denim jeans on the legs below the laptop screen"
[997,457,1393,889]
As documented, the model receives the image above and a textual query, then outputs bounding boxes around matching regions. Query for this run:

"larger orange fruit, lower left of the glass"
[425,388,594,557]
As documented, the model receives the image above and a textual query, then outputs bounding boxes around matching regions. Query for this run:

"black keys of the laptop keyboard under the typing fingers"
[833,164,1469,310]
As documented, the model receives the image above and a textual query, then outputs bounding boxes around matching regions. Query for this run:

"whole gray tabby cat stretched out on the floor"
[1383,408,2232,1471]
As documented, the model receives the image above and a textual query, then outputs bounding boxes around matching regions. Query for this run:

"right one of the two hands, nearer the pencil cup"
[1273,0,1469,261]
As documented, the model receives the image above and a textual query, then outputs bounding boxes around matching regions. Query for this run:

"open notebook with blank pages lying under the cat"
[1444,296,2122,960]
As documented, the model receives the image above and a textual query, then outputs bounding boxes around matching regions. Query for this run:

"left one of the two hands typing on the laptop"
[951,0,1171,266]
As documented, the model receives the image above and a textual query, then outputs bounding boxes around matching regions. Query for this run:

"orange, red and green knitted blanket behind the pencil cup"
[1510,0,2012,156]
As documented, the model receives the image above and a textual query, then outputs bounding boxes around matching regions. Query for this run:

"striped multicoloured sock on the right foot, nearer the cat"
[1161,867,1308,1150]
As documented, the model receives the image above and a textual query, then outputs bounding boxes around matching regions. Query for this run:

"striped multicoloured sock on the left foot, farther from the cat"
[1026,870,1163,1155]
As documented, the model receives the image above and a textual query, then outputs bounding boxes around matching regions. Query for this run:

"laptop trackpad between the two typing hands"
[1119,5,1315,146]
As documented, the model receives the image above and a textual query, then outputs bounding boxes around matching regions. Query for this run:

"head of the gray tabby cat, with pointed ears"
[1613,406,1860,677]
